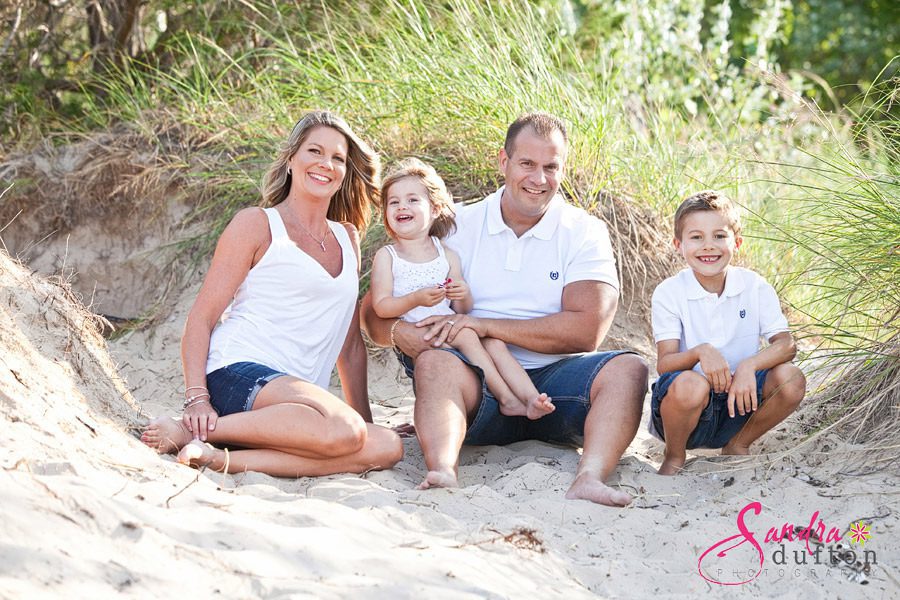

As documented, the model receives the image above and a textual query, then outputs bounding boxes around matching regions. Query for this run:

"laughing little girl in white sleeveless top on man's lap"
[372,158,556,419]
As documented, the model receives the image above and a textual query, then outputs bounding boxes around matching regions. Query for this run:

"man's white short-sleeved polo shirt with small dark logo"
[446,188,619,369]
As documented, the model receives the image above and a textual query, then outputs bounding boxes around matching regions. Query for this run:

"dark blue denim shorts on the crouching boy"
[650,369,769,450]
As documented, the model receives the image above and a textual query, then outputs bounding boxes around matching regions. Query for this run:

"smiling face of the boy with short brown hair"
[675,210,744,294]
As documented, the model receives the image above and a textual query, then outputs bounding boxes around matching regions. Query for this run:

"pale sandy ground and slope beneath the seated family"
[0,254,900,599]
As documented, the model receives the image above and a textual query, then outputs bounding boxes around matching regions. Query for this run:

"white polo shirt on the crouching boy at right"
[652,267,788,373]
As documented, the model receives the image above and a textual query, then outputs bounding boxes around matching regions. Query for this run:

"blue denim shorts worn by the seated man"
[395,348,634,447]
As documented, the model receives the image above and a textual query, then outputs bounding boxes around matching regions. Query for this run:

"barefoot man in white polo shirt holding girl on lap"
[362,113,647,506]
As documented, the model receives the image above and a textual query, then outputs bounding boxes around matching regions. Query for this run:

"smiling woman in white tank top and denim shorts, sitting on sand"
[141,111,403,477]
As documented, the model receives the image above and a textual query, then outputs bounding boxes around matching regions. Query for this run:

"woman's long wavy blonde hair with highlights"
[260,110,381,234]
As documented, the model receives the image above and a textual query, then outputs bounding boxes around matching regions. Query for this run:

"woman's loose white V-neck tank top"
[206,208,359,389]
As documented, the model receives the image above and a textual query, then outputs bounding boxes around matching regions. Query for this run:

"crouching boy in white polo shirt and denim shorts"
[650,191,806,475]
